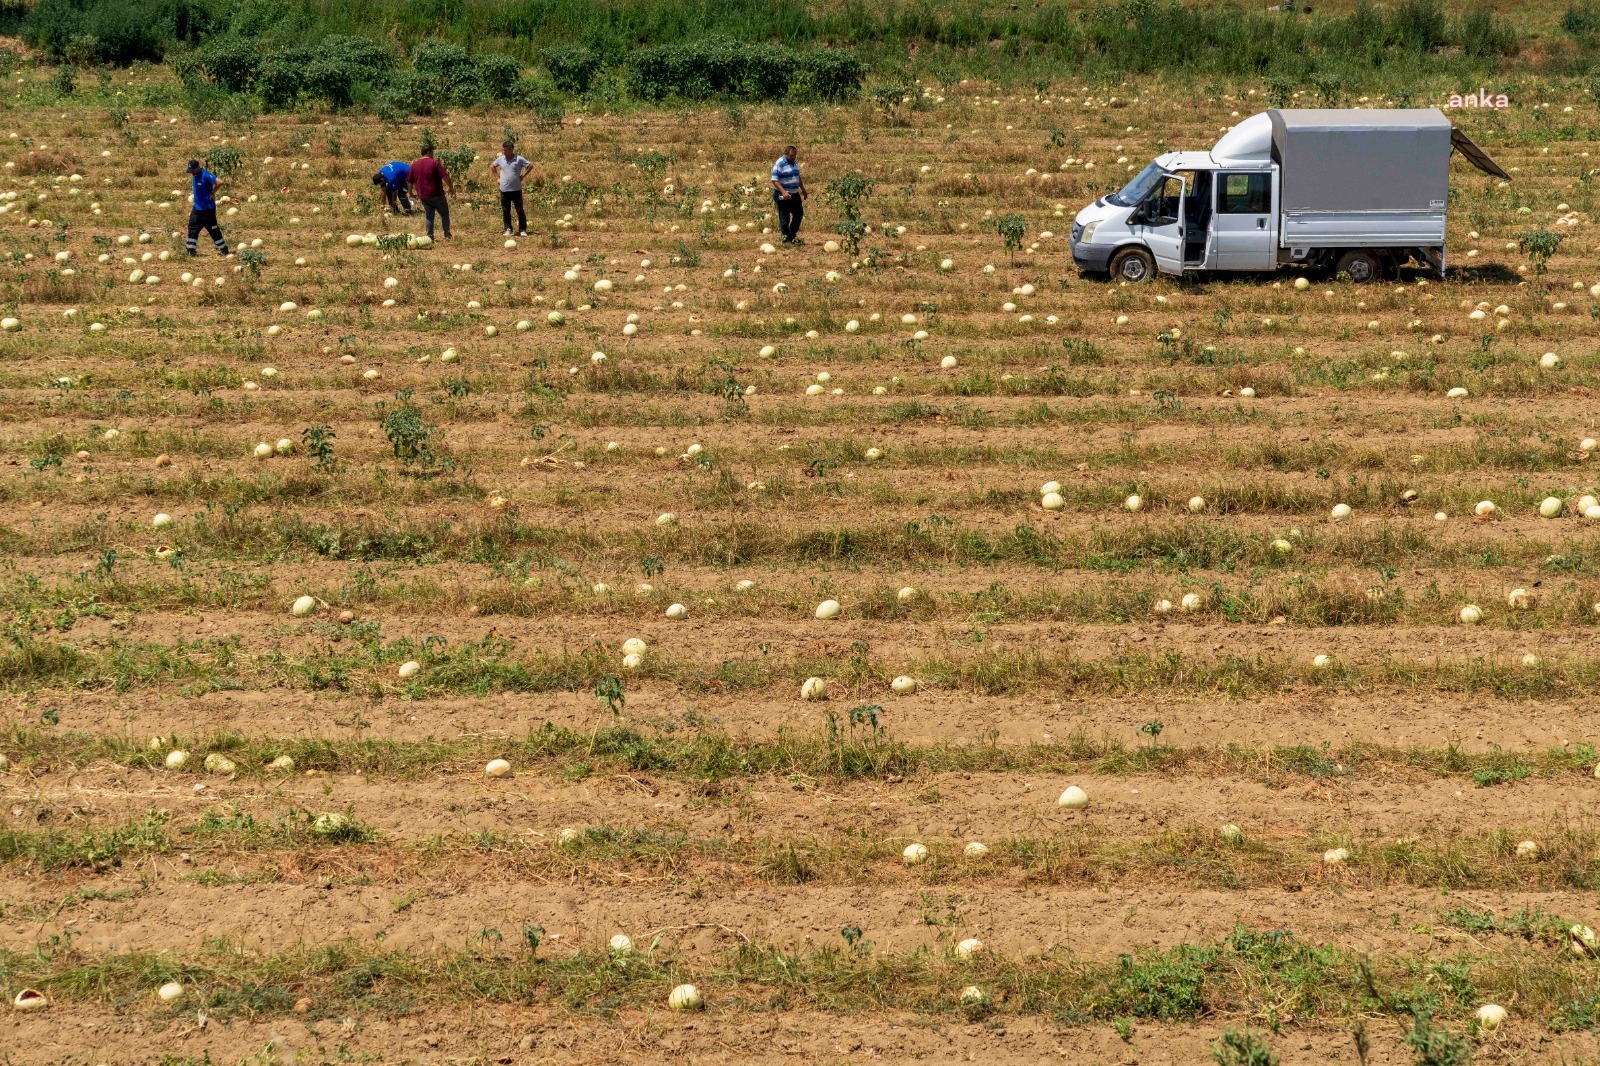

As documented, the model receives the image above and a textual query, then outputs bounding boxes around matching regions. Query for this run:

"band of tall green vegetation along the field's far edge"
[0,0,1542,80]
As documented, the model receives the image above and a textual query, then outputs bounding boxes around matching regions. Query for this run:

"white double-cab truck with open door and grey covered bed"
[1072,107,1509,282]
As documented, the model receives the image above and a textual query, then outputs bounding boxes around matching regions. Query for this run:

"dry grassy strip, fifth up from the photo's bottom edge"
[9,557,1600,632]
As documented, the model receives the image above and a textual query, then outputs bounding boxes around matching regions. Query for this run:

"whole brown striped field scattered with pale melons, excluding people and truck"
[0,60,1600,1066]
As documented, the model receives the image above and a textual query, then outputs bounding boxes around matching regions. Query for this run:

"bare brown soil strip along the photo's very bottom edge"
[8,1004,1555,1066]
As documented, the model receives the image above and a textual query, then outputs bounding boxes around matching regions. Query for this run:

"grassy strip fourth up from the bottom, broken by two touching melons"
[9,621,1600,706]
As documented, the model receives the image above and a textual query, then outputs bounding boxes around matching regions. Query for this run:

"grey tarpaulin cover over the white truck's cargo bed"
[1267,107,1451,221]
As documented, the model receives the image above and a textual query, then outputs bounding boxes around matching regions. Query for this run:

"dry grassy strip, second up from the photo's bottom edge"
[9,807,1600,892]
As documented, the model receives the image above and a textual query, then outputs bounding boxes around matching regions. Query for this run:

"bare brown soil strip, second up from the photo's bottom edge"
[0,855,1600,962]
